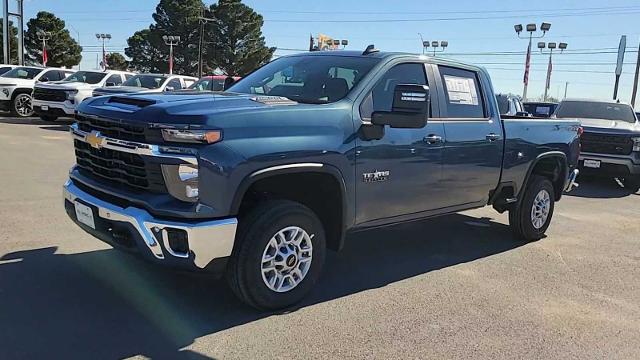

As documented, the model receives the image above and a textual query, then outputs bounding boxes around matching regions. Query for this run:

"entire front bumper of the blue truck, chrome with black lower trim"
[63,180,238,270]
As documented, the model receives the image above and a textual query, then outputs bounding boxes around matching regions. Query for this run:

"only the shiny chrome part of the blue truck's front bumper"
[63,180,238,269]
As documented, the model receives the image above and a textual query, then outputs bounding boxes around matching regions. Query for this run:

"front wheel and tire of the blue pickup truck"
[226,200,326,310]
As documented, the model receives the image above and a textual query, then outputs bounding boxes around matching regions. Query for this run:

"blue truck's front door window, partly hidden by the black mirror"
[360,63,428,121]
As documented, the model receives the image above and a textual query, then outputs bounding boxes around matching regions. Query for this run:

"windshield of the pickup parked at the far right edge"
[556,101,636,123]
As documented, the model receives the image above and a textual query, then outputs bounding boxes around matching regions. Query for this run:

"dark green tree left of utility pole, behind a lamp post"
[125,0,204,75]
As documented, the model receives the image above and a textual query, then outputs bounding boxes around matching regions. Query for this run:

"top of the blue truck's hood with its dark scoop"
[78,92,304,126]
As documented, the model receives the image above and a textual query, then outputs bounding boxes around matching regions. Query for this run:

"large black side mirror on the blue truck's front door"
[371,84,429,129]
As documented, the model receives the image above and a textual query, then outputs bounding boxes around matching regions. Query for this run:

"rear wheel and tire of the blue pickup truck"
[509,175,555,241]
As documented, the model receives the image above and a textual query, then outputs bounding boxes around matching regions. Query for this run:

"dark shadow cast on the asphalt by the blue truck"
[0,214,524,359]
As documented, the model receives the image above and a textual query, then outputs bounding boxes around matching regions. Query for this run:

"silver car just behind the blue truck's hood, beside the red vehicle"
[93,74,198,96]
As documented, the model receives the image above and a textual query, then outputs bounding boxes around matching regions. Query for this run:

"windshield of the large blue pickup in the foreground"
[229,55,380,104]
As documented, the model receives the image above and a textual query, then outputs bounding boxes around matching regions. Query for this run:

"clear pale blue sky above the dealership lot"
[10,0,640,109]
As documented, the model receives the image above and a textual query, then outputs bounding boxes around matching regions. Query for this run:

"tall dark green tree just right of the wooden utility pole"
[207,0,275,76]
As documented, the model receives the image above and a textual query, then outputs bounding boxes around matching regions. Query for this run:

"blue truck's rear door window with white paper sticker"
[438,66,485,119]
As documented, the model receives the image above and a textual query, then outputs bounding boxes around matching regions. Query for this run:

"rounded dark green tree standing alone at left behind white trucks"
[24,11,82,67]
